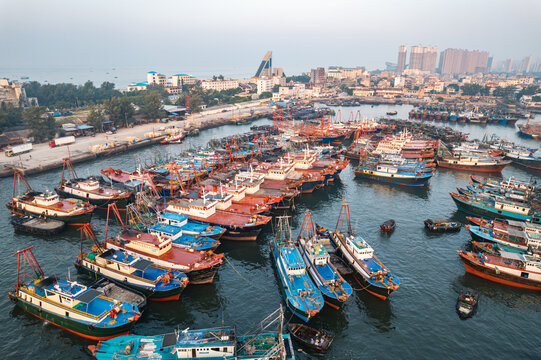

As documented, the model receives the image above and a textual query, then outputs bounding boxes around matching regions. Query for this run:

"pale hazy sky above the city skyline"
[0,0,541,77]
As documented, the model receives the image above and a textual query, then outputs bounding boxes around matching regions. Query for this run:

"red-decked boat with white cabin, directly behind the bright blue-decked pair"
[165,198,271,241]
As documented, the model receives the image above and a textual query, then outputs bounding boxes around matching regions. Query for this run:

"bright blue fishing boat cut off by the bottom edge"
[92,309,295,360]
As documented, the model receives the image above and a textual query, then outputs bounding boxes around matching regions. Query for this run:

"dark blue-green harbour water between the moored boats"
[0,106,541,359]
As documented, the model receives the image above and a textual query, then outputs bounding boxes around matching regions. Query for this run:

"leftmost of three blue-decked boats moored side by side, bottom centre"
[271,216,325,322]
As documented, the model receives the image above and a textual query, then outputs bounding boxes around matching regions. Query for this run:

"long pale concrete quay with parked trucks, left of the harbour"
[0,101,272,178]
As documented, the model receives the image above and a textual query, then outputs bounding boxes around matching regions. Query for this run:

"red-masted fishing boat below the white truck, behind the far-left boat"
[55,158,132,209]
